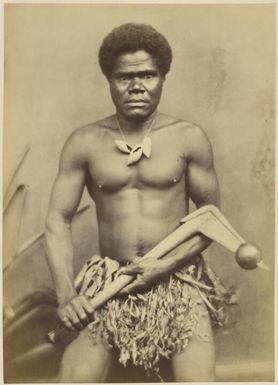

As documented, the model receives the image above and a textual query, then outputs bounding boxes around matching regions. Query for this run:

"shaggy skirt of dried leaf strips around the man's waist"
[76,255,235,373]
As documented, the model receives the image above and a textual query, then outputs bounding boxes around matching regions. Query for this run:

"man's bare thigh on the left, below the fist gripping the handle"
[59,329,112,382]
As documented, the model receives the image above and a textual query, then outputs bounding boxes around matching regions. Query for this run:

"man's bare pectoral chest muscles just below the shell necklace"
[89,134,185,192]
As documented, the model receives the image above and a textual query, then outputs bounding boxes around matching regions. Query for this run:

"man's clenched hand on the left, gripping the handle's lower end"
[57,295,95,331]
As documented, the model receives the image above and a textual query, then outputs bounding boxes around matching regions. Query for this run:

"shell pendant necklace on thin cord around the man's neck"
[115,117,155,166]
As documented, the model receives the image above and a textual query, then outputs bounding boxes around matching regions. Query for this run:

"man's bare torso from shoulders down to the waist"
[75,114,198,261]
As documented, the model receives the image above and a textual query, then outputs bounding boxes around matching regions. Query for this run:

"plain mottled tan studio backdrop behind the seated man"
[4,4,275,378]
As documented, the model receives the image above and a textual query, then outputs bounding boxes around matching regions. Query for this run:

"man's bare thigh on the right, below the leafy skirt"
[172,304,215,382]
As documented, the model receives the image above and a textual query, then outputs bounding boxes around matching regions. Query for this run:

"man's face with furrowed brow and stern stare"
[109,51,164,120]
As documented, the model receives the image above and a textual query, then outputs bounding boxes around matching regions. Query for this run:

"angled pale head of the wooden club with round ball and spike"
[181,205,269,271]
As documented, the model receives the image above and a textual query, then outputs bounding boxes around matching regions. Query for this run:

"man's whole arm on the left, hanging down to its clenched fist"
[45,133,93,330]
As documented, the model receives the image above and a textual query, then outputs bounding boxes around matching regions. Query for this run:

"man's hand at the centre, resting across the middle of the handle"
[116,258,170,295]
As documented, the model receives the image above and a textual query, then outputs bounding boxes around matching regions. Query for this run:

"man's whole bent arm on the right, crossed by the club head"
[121,126,219,294]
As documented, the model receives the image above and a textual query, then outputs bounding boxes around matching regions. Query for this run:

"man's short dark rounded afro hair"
[99,23,172,79]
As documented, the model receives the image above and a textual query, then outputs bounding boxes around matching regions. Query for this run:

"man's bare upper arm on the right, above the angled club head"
[187,127,219,208]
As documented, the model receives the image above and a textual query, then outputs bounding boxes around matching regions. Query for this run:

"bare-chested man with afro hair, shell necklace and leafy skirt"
[46,24,229,382]
